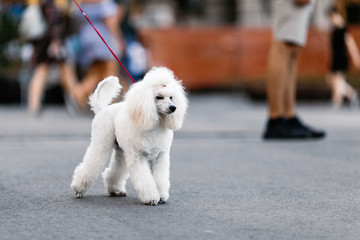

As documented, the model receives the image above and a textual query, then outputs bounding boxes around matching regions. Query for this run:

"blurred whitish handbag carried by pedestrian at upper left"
[19,4,47,41]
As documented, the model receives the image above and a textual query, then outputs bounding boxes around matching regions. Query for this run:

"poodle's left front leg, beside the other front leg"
[127,155,160,206]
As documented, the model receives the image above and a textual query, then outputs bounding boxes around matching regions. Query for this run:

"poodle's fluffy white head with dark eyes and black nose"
[125,67,188,130]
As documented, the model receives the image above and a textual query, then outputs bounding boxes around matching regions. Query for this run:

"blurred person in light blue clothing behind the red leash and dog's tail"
[71,0,125,109]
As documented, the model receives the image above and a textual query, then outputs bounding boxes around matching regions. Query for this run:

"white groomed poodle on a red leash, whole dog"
[71,67,188,205]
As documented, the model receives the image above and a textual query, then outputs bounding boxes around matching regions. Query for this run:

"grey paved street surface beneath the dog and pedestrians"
[0,94,360,240]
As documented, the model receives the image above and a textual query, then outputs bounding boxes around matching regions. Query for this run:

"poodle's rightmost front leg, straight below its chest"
[152,152,170,204]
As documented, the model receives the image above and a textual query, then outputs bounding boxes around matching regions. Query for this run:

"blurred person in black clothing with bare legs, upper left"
[25,0,77,114]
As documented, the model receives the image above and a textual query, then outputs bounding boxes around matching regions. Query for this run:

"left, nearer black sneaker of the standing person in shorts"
[264,118,311,139]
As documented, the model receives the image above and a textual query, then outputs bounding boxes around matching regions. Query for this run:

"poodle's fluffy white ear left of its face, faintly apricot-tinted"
[126,82,159,130]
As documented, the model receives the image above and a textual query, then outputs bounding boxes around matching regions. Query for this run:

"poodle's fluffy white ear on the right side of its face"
[163,81,188,130]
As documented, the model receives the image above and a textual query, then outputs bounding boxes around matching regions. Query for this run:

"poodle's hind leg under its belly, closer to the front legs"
[101,146,130,197]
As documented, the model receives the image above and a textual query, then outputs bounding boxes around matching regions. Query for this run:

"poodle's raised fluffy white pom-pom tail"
[89,76,122,114]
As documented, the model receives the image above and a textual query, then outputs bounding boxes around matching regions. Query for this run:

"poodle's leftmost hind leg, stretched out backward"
[71,119,115,198]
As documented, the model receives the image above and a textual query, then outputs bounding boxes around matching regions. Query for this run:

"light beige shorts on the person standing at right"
[273,0,315,46]
